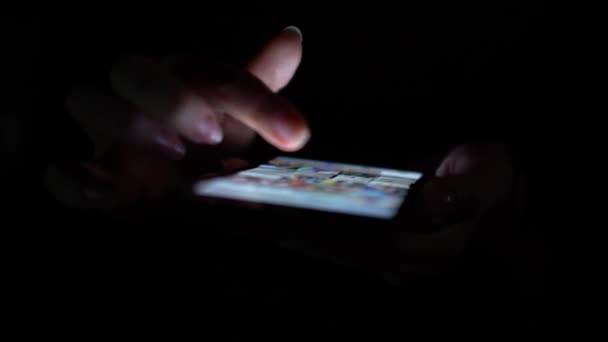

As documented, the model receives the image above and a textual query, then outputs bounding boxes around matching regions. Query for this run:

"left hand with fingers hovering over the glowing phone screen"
[46,28,310,208]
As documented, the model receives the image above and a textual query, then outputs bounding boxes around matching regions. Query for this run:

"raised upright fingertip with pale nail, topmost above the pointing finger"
[247,26,302,92]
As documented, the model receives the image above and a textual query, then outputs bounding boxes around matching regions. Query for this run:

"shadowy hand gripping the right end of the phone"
[399,143,523,269]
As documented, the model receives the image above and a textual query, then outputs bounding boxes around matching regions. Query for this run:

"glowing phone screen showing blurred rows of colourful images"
[194,157,422,219]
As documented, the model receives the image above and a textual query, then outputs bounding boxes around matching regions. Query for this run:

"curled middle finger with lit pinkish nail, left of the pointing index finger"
[110,56,223,144]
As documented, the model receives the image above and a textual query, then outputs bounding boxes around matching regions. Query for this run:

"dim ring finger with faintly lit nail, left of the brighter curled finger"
[67,86,185,158]
